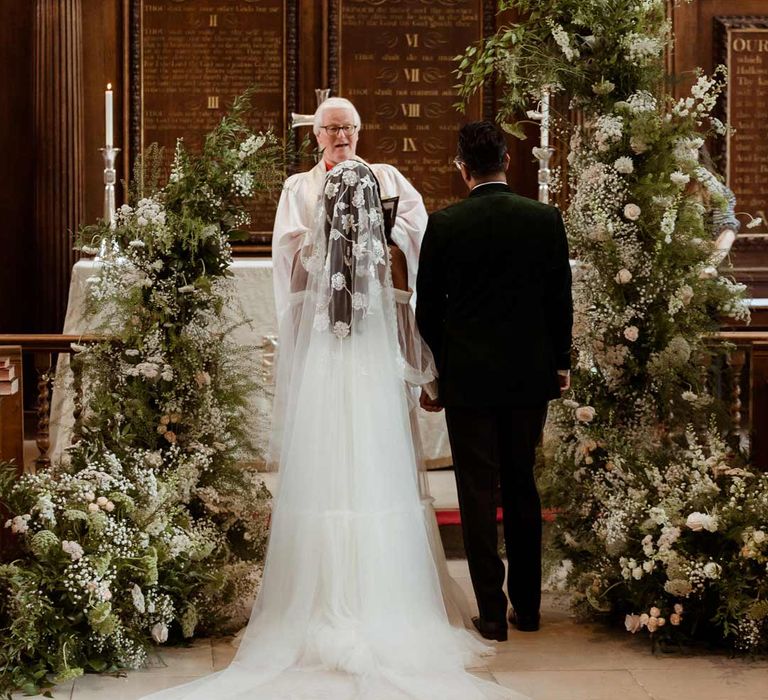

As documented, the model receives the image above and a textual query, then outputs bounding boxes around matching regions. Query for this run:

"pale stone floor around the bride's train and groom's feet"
[19,561,768,700]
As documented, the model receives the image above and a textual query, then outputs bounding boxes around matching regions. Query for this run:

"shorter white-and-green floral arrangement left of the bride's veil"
[0,95,285,696]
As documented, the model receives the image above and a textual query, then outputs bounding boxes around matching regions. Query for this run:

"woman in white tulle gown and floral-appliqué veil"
[145,161,522,700]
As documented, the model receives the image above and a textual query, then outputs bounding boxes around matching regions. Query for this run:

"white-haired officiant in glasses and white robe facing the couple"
[272,97,427,321]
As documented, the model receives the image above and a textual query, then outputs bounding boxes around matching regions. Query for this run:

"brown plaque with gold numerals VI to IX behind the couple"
[340,0,484,211]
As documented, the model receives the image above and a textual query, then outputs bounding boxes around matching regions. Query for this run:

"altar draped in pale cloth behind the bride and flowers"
[50,258,452,469]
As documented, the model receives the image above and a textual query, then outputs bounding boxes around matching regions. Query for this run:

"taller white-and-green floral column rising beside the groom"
[458,0,768,652]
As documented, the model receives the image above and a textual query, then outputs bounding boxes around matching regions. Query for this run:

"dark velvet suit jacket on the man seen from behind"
[416,183,573,408]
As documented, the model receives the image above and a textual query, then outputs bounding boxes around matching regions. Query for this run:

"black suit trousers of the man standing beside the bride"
[445,403,547,624]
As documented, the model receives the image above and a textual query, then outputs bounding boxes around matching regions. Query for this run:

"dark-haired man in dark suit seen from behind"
[416,122,573,641]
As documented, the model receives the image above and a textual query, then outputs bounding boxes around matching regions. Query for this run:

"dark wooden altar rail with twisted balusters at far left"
[0,334,103,470]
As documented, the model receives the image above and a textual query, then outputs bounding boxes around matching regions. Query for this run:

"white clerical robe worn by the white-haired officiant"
[272,160,427,322]
